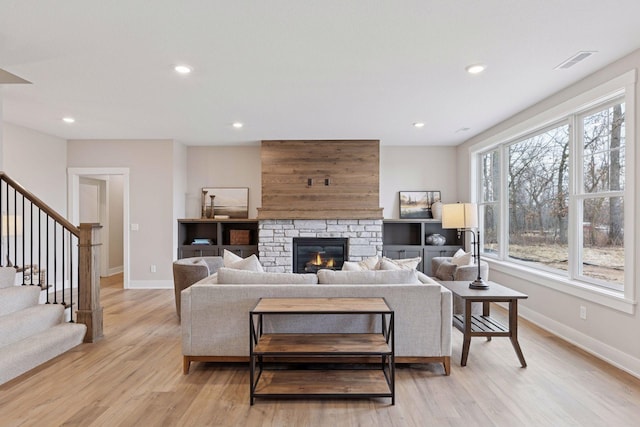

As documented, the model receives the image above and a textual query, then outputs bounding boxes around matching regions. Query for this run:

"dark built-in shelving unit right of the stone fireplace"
[382,219,464,276]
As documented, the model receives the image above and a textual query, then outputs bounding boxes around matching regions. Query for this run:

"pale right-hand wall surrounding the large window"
[458,50,640,377]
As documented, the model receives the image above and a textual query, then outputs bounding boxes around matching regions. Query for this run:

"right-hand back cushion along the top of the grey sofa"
[318,269,420,285]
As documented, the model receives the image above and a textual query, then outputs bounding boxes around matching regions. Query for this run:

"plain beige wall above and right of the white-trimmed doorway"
[67,140,175,287]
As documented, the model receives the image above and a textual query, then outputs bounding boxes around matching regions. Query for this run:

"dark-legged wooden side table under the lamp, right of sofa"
[438,280,528,368]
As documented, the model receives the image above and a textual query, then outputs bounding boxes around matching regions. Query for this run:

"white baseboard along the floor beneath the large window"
[518,305,640,378]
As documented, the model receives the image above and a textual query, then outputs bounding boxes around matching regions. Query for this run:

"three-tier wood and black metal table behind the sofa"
[249,298,395,405]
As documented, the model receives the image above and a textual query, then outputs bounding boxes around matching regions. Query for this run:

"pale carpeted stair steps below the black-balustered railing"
[0,267,87,384]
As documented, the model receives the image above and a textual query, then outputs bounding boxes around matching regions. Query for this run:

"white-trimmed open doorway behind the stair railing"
[67,168,130,289]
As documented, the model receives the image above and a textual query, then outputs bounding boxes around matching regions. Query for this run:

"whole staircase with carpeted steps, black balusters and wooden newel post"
[0,172,102,384]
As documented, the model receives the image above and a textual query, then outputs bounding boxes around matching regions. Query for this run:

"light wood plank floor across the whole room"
[0,276,640,427]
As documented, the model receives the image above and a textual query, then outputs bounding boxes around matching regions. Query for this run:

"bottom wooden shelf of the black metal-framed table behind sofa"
[253,369,393,398]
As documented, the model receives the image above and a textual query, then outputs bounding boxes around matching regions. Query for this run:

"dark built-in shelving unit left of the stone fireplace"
[178,218,258,259]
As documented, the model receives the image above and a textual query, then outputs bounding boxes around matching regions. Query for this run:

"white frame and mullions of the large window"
[468,69,640,314]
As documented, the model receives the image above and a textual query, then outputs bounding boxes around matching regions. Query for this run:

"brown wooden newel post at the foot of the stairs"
[77,223,103,342]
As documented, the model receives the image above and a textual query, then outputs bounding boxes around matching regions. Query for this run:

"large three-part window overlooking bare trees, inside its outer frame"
[477,96,627,291]
